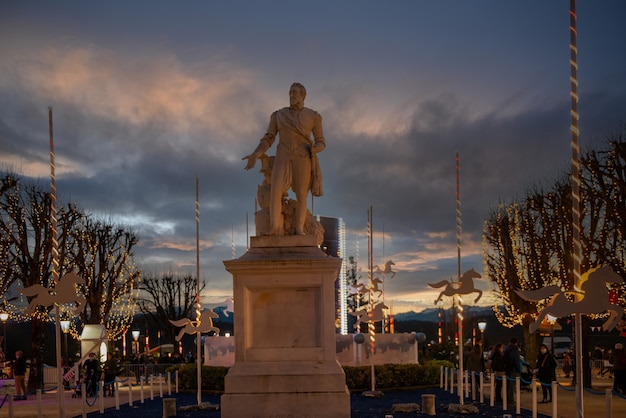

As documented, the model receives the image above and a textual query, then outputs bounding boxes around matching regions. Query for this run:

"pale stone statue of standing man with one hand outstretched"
[242,83,326,235]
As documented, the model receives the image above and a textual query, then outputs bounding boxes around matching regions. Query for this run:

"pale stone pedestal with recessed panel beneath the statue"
[221,236,350,418]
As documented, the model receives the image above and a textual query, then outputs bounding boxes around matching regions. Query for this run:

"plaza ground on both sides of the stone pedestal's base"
[0,370,626,418]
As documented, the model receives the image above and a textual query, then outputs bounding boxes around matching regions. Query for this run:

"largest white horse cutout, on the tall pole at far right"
[515,266,624,332]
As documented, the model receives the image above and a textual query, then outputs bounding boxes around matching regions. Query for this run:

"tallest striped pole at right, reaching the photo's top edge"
[569,0,585,418]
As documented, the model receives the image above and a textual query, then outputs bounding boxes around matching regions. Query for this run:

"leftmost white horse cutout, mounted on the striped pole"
[20,271,87,315]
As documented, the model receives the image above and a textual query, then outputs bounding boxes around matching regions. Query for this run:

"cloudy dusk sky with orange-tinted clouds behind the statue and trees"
[0,0,626,312]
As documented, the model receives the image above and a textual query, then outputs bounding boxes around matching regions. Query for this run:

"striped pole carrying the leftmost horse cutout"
[48,107,65,417]
